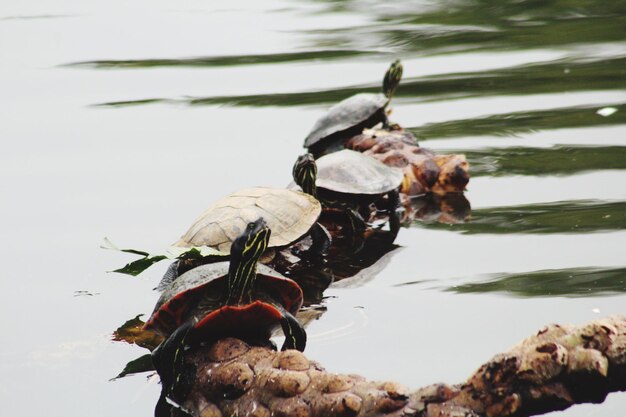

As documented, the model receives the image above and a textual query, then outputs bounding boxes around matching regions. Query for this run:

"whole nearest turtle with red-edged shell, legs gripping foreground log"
[149,218,306,416]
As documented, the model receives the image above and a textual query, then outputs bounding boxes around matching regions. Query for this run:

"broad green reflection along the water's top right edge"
[302,0,626,54]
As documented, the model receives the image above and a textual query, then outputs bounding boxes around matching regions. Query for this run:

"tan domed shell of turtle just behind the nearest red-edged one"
[174,187,322,253]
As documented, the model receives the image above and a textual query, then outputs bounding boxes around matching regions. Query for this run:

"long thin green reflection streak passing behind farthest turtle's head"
[94,57,626,108]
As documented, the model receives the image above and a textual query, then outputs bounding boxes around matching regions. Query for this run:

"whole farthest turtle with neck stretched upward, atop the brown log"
[304,60,402,157]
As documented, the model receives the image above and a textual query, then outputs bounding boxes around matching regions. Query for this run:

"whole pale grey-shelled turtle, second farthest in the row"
[292,149,404,231]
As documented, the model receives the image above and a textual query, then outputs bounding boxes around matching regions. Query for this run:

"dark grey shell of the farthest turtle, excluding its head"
[304,93,389,152]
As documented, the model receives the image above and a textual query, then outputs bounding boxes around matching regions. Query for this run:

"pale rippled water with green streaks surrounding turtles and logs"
[0,0,626,417]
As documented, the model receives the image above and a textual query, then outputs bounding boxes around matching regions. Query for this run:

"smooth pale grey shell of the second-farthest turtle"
[315,149,404,195]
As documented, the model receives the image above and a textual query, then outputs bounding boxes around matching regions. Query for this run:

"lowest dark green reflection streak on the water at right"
[447,268,626,297]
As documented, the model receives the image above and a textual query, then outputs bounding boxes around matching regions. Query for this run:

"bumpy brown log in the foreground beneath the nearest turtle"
[174,316,626,417]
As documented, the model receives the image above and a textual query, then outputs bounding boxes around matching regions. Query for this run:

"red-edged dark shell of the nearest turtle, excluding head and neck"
[144,262,302,336]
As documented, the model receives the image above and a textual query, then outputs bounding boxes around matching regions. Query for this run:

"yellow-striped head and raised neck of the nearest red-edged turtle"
[227,217,271,304]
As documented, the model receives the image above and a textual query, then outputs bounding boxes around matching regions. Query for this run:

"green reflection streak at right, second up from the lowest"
[415,200,626,234]
